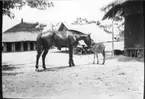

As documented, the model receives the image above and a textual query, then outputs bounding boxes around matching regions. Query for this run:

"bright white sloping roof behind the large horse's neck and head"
[64,23,112,42]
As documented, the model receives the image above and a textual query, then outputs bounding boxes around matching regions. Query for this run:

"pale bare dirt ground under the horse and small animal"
[2,46,144,99]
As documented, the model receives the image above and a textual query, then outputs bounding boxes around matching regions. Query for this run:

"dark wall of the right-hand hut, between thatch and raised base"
[124,14,144,48]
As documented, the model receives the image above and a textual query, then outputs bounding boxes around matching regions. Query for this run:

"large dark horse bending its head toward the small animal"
[36,30,91,70]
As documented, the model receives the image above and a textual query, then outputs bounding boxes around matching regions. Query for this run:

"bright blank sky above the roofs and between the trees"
[3,0,113,32]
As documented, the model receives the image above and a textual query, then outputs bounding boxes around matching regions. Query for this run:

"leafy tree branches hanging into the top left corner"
[2,0,54,18]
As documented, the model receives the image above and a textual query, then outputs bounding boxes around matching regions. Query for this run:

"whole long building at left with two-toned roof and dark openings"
[2,19,41,52]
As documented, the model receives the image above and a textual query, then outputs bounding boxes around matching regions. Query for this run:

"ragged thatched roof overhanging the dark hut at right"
[101,0,144,20]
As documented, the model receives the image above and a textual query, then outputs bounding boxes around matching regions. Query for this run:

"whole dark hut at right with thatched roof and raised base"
[102,0,144,57]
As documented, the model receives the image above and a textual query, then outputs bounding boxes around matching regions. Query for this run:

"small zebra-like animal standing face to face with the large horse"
[91,42,105,65]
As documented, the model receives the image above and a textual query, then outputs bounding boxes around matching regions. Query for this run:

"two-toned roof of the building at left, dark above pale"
[2,20,41,42]
